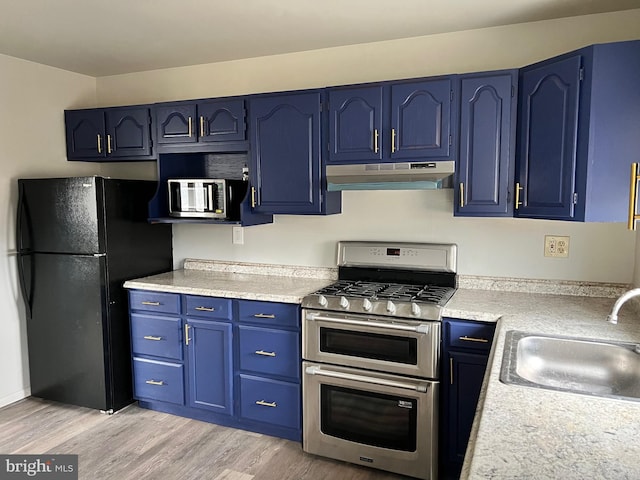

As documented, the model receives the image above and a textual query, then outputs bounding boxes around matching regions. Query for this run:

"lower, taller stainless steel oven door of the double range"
[302,361,439,480]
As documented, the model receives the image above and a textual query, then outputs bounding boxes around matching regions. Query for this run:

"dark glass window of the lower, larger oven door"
[320,385,417,452]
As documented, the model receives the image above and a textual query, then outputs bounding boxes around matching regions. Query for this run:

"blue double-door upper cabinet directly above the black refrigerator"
[65,105,155,162]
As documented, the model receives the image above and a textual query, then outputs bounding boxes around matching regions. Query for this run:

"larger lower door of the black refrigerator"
[25,253,119,410]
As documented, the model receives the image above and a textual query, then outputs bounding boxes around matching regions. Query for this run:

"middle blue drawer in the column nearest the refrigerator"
[131,313,182,360]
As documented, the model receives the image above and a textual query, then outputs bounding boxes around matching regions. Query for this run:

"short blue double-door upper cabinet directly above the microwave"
[155,98,246,150]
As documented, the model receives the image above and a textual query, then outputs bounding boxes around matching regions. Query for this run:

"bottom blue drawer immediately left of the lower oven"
[240,375,300,429]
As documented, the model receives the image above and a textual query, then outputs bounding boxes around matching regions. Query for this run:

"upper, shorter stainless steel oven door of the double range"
[302,310,441,379]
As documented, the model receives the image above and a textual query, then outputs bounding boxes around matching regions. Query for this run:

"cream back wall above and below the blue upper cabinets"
[97,10,640,283]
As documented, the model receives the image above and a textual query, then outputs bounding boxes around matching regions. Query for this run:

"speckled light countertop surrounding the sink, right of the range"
[444,289,640,480]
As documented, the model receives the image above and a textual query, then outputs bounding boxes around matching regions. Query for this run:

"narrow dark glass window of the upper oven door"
[320,327,418,365]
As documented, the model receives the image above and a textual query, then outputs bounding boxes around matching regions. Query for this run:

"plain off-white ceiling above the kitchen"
[0,0,640,77]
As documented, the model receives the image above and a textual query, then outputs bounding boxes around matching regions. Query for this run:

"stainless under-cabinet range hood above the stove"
[326,161,455,191]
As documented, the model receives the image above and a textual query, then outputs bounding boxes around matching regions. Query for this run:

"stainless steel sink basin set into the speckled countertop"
[500,330,640,401]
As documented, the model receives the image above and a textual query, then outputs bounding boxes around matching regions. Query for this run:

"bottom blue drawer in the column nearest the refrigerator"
[133,358,184,405]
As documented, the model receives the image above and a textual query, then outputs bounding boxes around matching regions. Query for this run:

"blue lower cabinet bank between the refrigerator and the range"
[129,291,302,441]
